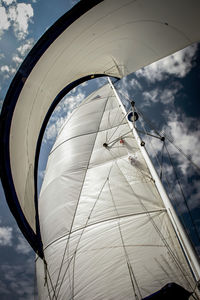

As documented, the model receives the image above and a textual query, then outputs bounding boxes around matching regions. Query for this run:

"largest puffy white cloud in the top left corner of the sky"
[7,3,34,40]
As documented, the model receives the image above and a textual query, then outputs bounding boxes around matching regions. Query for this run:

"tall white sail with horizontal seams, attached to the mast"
[37,85,199,300]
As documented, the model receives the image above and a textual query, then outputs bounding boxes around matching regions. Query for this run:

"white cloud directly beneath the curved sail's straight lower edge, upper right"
[135,44,197,83]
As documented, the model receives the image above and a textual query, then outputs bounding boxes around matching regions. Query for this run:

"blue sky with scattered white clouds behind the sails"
[0,0,200,300]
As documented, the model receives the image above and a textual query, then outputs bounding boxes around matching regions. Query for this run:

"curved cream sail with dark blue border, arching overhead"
[0,0,200,251]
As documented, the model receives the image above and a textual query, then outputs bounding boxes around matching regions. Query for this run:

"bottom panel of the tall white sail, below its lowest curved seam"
[39,212,194,300]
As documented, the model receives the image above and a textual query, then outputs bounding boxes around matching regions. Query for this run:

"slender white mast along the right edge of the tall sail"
[108,78,200,281]
